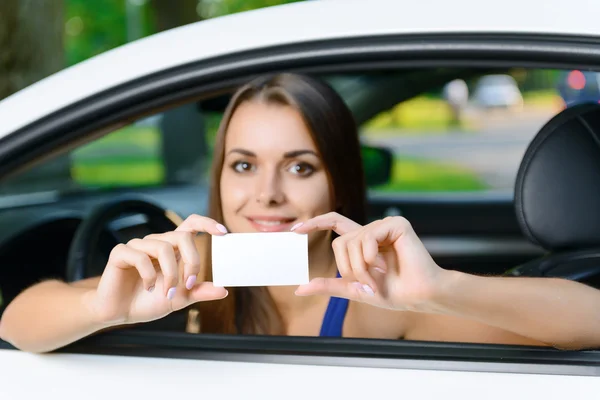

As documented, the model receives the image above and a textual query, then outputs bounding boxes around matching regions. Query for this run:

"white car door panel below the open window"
[0,350,600,400]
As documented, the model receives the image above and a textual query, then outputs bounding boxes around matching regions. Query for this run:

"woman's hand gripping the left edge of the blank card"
[90,215,227,325]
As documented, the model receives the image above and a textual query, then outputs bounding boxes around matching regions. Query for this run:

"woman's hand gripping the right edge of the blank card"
[294,213,446,311]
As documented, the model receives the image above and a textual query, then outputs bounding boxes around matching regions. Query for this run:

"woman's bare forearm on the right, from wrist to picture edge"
[406,271,600,349]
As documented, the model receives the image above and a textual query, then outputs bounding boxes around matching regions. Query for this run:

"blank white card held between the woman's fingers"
[212,232,309,287]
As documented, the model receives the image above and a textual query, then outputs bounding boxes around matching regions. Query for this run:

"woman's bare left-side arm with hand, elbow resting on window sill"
[0,215,227,352]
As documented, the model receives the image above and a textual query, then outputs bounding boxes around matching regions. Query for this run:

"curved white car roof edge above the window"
[0,0,600,138]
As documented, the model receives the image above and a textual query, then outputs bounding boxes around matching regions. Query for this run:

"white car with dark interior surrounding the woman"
[0,0,600,400]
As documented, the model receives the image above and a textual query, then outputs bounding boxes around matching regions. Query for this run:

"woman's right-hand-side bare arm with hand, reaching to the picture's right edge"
[294,213,600,349]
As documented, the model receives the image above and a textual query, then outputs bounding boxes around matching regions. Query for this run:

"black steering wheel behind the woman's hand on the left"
[66,196,177,282]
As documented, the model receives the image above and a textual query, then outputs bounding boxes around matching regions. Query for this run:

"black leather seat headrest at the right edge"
[515,104,600,250]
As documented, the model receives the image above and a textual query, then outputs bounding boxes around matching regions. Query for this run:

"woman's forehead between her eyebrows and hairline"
[225,101,315,151]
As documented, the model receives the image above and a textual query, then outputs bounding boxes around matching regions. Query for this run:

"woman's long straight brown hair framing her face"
[196,73,366,335]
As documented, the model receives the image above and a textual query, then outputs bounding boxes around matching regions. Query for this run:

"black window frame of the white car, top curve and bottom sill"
[0,34,600,375]
